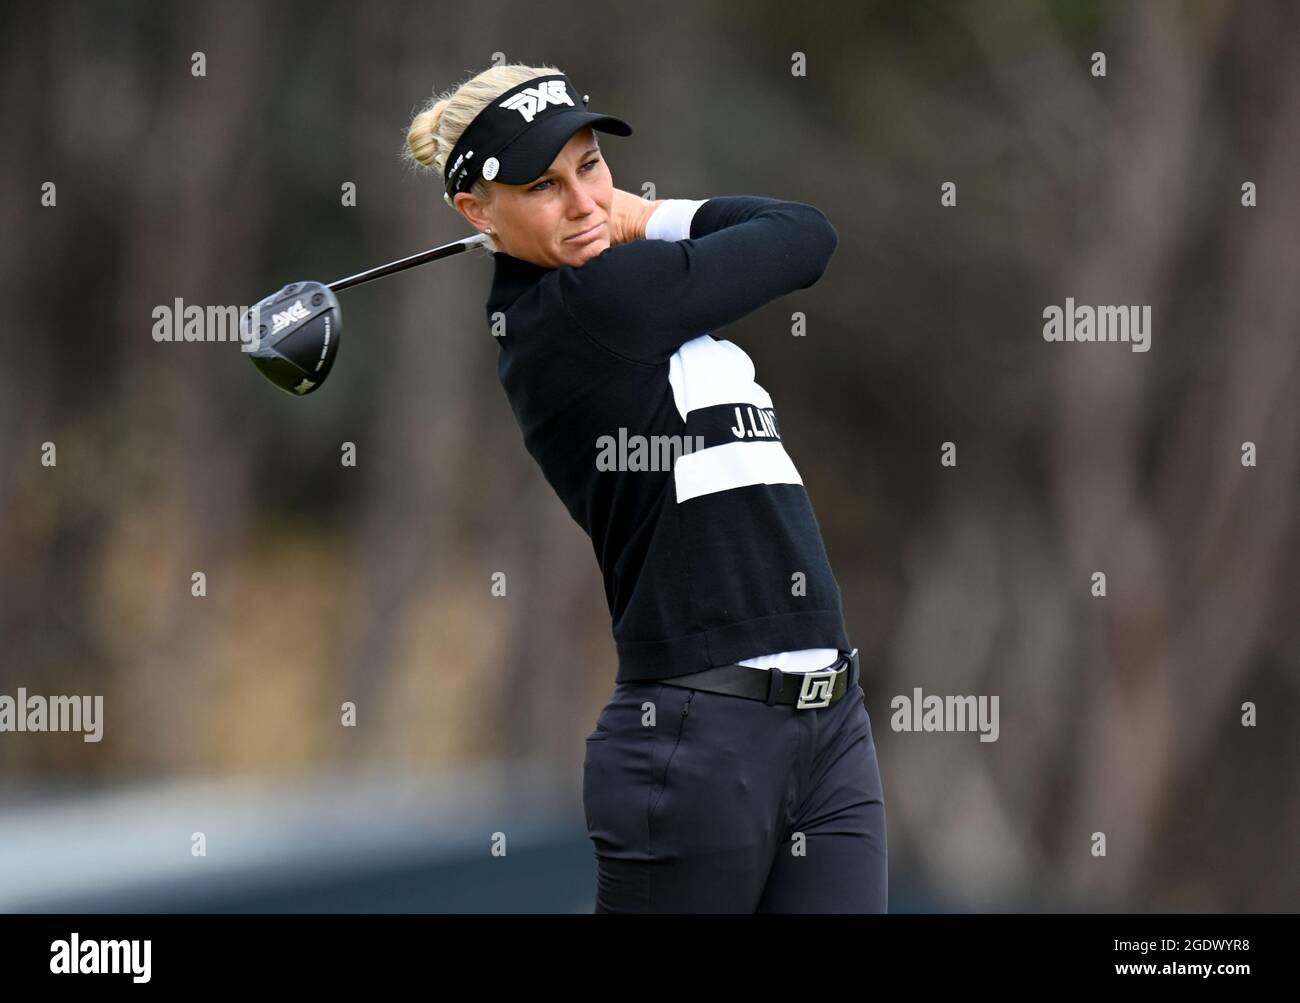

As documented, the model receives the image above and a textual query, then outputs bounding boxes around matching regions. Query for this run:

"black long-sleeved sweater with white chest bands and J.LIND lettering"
[488,196,850,682]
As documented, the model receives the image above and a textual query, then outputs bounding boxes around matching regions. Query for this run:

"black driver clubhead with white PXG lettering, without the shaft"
[243,282,343,398]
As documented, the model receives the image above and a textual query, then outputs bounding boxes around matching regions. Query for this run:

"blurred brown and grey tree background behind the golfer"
[0,0,1300,909]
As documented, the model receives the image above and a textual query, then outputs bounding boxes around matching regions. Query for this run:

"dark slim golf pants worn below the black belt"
[582,682,888,912]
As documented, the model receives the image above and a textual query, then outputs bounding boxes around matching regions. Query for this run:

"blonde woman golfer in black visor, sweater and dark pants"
[407,65,887,912]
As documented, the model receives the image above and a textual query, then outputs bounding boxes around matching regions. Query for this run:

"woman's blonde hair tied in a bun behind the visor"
[402,62,560,255]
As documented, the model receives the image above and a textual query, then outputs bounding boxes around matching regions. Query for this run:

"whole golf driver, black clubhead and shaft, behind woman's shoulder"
[243,234,488,398]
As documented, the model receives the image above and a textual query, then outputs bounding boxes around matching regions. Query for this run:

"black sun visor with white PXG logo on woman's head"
[443,73,632,204]
